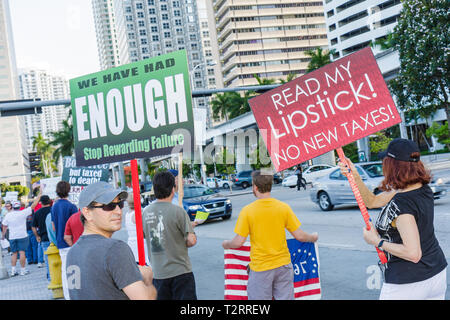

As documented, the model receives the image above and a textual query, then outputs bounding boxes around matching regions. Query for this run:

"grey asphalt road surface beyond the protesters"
[114,169,450,300]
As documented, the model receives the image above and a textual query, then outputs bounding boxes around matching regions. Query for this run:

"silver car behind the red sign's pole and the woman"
[309,161,446,211]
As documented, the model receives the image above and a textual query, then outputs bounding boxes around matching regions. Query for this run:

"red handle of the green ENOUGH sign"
[130,159,145,266]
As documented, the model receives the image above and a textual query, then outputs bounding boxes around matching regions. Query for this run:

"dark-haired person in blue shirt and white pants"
[51,181,78,300]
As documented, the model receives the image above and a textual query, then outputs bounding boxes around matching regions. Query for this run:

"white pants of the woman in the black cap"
[380,268,447,300]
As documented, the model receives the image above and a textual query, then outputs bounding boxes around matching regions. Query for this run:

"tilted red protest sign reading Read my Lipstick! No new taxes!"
[249,48,401,171]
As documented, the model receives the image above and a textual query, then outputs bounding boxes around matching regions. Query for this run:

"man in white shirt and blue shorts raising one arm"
[2,189,42,277]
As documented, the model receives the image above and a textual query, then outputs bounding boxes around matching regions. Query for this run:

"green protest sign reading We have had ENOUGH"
[70,50,194,167]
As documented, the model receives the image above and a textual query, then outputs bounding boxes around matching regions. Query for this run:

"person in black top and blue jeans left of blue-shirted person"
[31,195,52,280]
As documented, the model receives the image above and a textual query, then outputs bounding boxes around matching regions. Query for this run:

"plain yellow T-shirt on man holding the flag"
[234,198,301,271]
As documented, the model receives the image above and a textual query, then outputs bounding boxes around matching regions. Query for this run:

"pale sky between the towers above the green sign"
[9,0,100,80]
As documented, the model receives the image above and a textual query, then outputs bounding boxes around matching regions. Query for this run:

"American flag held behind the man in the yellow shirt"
[224,239,322,300]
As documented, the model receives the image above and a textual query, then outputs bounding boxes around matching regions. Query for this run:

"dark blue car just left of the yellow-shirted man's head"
[183,184,233,221]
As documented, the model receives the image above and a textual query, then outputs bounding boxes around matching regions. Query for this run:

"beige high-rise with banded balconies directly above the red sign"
[213,0,328,87]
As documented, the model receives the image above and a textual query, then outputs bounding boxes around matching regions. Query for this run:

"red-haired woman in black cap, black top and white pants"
[339,139,447,300]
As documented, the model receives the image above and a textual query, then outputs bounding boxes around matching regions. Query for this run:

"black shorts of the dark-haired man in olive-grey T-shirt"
[153,272,197,300]
